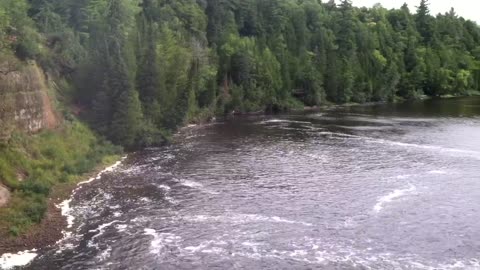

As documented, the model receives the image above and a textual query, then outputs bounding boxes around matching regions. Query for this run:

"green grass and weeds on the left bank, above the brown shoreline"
[0,121,122,236]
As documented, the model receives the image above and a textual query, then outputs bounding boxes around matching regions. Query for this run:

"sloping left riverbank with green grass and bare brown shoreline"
[0,120,122,262]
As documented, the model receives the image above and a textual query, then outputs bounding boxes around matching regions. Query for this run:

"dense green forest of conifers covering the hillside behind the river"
[0,0,480,147]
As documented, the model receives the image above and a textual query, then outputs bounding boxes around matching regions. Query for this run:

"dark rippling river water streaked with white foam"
[27,98,480,270]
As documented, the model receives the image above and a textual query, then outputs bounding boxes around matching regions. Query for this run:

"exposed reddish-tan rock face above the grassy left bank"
[0,59,57,139]
